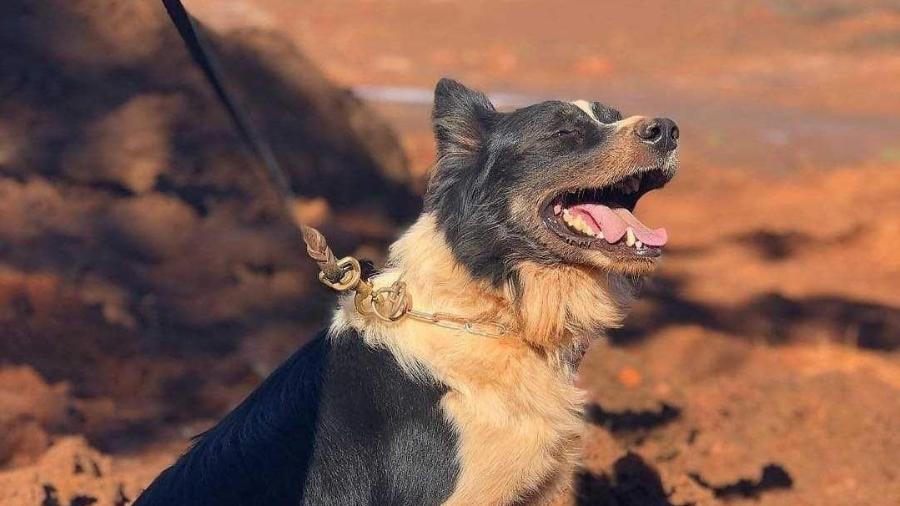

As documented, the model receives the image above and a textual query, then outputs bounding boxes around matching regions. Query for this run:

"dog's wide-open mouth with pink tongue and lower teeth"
[542,168,673,258]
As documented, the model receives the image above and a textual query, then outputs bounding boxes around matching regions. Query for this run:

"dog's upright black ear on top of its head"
[432,78,497,157]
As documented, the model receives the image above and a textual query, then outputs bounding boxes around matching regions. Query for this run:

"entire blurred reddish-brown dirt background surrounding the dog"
[0,0,900,506]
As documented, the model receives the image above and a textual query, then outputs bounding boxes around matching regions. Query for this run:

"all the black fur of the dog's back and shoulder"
[135,331,458,506]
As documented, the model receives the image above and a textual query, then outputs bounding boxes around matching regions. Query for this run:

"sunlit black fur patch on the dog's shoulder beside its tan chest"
[307,330,459,505]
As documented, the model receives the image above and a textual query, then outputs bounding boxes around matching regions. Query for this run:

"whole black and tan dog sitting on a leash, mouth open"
[136,79,678,506]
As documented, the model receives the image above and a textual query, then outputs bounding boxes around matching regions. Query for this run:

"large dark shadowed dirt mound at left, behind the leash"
[0,0,420,456]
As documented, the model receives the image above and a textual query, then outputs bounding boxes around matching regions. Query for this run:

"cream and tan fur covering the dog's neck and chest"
[332,214,628,505]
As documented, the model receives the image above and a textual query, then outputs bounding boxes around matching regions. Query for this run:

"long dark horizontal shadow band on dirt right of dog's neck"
[612,276,900,351]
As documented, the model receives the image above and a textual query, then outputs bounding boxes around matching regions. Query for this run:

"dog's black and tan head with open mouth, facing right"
[425,79,678,283]
